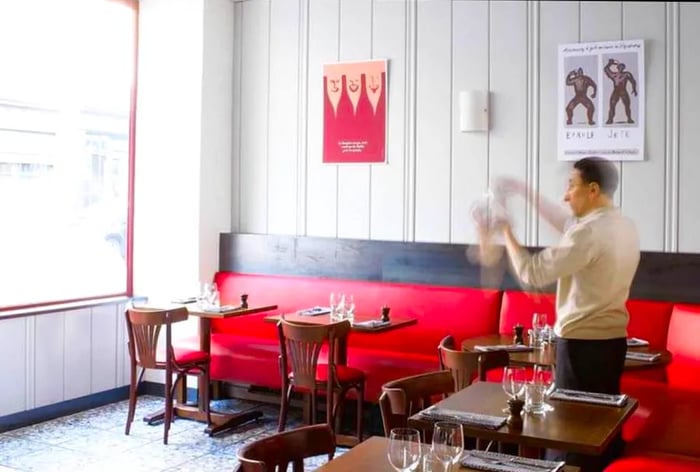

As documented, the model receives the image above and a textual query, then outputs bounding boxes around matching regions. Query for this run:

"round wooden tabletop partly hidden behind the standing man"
[462,334,671,370]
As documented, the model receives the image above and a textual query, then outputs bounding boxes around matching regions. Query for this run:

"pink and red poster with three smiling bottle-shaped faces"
[323,60,387,164]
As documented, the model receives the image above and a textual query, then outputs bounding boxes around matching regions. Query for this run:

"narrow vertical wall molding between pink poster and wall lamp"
[403,0,418,242]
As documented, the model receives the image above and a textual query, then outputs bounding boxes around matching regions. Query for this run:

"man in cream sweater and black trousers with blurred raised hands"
[484,157,639,470]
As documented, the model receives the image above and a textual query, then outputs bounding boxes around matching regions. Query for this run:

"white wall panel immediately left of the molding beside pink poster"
[267,1,304,234]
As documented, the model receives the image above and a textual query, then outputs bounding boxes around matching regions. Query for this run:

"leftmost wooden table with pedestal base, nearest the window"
[144,305,277,436]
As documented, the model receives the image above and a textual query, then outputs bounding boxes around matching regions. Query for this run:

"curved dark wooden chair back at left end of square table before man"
[379,370,455,436]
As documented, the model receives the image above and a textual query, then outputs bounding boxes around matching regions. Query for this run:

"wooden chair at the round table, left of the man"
[438,336,510,391]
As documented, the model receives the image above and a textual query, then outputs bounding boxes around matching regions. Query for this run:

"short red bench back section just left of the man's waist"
[498,290,556,334]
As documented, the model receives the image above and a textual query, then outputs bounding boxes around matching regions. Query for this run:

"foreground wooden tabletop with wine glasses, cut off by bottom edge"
[316,436,580,472]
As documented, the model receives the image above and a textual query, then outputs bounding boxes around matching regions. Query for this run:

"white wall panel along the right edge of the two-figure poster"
[620,2,666,251]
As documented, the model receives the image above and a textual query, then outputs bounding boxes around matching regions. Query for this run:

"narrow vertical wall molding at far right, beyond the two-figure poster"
[664,2,680,252]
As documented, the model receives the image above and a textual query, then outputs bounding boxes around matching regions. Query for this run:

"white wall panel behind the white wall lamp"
[450,1,489,243]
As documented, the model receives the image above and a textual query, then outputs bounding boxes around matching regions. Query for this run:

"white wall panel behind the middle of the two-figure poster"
[580,2,625,208]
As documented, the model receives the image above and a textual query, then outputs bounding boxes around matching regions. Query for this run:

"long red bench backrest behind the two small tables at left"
[212,272,500,359]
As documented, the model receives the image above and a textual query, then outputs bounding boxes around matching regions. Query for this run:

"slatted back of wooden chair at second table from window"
[277,319,350,389]
